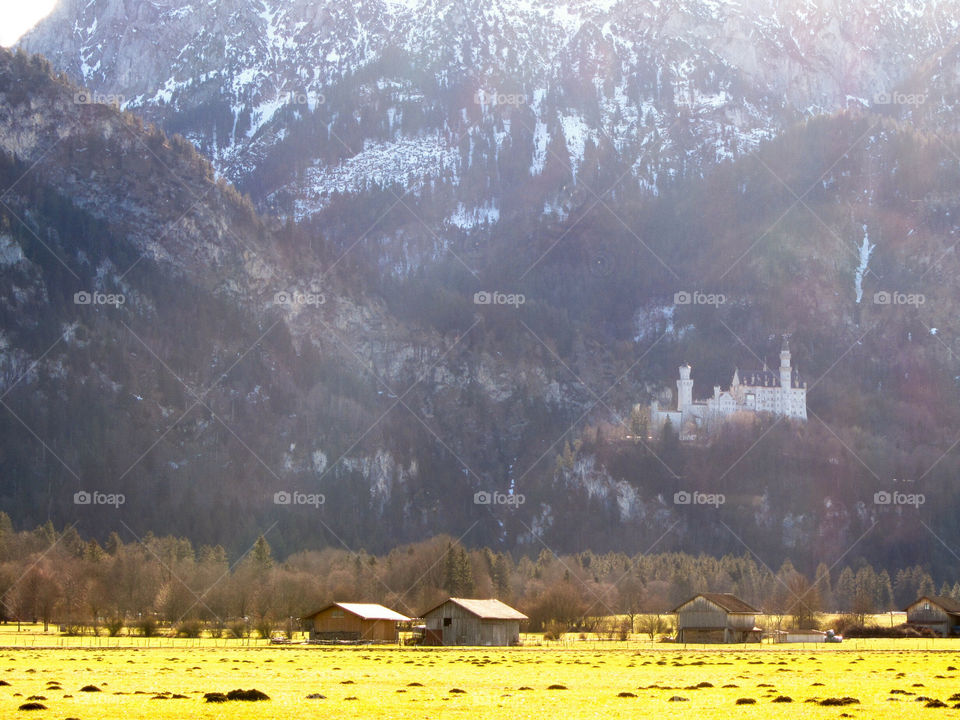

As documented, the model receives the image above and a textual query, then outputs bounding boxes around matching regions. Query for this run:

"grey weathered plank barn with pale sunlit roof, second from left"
[423,598,527,645]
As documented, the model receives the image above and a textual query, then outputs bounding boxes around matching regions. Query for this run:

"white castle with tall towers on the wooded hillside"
[650,338,807,440]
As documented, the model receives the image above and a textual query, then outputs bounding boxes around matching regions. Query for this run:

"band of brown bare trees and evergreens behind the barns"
[0,513,960,637]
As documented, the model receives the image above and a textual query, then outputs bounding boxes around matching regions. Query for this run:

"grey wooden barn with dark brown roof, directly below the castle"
[673,593,762,643]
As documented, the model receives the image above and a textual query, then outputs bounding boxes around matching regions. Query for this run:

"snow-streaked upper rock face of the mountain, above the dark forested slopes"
[22,0,960,256]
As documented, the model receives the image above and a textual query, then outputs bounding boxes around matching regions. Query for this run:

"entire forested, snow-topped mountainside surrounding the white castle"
[0,0,960,565]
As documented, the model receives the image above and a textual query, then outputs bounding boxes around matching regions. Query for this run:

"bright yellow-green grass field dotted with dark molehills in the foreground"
[0,639,960,720]
